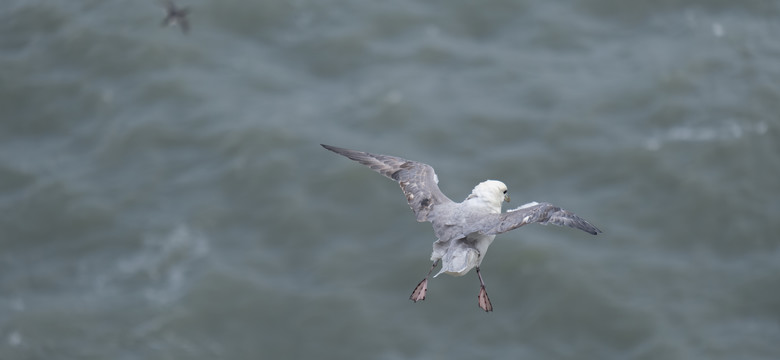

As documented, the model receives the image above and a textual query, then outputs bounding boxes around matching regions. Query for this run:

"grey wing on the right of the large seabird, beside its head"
[470,202,601,235]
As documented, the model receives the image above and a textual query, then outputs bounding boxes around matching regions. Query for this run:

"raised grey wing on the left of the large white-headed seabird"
[321,144,452,222]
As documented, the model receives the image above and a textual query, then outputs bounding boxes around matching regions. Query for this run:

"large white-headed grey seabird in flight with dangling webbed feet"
[321,144,601,312]
